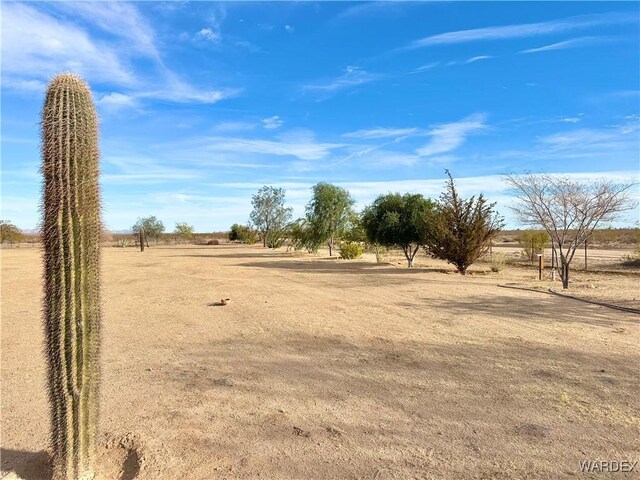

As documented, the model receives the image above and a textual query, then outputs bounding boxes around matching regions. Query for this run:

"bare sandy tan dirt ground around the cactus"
[1,245,640,480]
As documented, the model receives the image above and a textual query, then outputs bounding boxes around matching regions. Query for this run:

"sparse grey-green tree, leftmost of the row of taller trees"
[250,185,293,247]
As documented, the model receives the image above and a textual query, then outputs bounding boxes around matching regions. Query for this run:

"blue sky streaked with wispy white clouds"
[1,2,640,232]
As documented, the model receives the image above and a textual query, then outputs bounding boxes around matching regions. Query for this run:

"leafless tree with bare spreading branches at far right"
[506,173,637,289]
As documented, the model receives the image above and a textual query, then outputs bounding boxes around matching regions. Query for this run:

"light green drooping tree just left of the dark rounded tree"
[307,182,355,256]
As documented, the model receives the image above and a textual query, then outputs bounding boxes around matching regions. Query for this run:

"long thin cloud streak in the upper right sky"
[403,13,638,50]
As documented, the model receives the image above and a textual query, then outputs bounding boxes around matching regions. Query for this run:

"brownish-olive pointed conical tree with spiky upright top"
[425,170,504,275]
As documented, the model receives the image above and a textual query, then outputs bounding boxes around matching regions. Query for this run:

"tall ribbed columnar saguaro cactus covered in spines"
[42,73,101,480]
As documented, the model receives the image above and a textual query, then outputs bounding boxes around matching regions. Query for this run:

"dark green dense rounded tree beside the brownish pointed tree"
[362,193,434,268]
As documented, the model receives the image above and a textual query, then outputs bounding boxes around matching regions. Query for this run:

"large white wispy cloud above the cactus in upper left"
[2,2,240,108]
